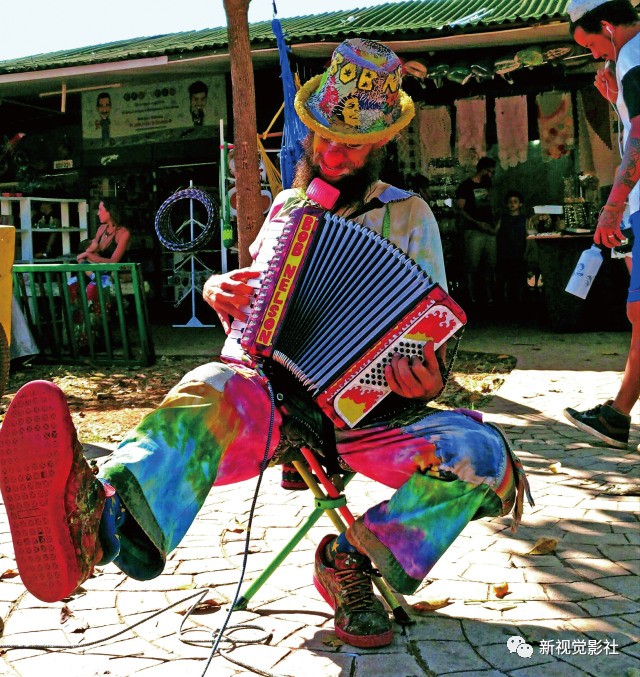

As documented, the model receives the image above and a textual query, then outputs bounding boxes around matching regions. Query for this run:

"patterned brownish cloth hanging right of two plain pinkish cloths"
[536,92,574,162]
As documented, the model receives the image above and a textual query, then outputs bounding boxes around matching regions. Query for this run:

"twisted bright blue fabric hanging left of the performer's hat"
[271,14,308,188]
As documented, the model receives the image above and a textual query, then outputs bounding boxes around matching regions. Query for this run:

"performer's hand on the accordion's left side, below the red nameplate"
[202,268,261,334]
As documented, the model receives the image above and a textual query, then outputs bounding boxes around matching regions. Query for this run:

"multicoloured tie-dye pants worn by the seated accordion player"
[102,363,520,580]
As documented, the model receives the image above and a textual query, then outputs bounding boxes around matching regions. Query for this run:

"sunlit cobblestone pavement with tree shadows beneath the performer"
[0,330,640,677]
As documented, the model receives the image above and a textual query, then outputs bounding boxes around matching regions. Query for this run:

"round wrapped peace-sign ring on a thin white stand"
[155,188,218,252]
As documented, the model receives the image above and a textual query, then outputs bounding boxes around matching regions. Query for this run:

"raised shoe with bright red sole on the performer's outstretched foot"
[0,381,105,602]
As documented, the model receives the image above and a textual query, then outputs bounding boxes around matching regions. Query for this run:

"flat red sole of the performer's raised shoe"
[0,381,81,602]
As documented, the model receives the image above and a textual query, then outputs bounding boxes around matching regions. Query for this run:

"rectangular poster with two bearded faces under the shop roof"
[82,75,227,150]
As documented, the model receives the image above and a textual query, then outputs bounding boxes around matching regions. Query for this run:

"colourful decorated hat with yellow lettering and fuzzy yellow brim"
[295,38,415,144]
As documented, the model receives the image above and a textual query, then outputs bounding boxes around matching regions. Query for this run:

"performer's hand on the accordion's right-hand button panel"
[384,341,444,400]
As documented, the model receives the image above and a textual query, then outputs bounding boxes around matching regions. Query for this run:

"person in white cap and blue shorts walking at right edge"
[564,0,640,449]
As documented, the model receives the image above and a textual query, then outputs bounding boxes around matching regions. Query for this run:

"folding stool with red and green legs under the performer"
[234,447,414,625]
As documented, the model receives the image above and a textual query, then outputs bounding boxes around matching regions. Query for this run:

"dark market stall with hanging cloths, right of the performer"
[398,40,628,331]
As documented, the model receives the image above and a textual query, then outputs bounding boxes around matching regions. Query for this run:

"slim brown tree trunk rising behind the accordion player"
[223,0,263,267]
